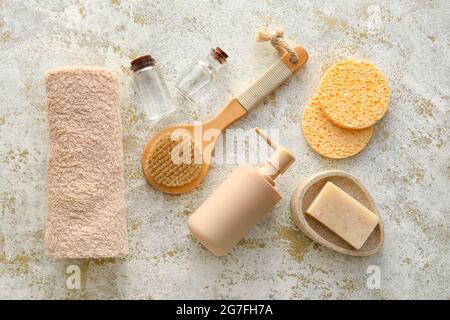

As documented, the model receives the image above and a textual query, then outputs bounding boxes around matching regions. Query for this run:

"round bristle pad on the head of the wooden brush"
[145,134,203,187]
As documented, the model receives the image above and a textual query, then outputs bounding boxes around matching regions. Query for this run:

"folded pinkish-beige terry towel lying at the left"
[45,67,128,258]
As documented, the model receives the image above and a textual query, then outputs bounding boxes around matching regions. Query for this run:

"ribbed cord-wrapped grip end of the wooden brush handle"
[237,47,308,111]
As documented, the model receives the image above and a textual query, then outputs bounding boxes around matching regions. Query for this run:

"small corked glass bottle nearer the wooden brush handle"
[176,47,228,102]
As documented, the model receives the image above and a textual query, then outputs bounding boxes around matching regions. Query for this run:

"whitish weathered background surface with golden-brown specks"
[0,0,450,299]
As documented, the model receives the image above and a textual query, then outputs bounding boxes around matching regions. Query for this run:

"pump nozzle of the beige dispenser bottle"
[255,128,295,183]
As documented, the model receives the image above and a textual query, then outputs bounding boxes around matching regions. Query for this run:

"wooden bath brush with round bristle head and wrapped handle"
[141,42,308,194]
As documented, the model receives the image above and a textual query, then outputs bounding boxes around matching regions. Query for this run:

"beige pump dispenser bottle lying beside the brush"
[188,128,295,256]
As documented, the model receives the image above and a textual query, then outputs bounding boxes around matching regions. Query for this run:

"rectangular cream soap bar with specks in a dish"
[306,181,380,249]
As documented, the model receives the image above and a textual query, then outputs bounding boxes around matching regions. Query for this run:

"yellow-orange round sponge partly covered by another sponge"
[302,97,373,159]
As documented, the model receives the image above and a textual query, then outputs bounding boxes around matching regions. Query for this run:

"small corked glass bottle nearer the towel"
[131,55,176,120]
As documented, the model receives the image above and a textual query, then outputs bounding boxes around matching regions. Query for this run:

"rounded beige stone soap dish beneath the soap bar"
[291,170,384,256]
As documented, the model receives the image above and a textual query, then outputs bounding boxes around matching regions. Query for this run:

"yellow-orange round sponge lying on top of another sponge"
[316,60,389,129]
